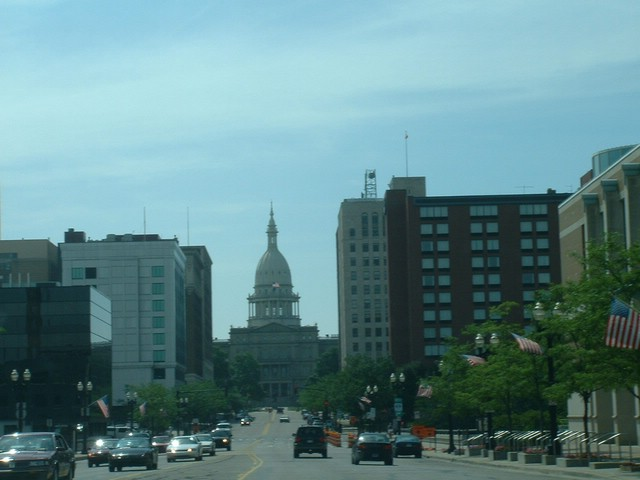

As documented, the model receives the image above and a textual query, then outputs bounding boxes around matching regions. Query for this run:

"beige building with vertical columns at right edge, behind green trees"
[559,145,640,444]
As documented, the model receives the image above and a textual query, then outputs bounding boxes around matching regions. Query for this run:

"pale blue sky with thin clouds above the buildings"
[0,0,640,339]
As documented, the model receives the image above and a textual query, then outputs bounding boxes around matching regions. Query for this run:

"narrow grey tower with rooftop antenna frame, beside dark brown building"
[336,170,425,365]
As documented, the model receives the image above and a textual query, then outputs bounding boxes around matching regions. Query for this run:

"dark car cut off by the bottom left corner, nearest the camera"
[0,432,76,480]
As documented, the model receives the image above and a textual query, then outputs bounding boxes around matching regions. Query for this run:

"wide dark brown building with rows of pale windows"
[384,188,568,370]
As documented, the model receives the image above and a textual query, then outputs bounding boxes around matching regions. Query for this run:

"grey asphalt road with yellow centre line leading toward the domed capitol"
[76,412,560,480]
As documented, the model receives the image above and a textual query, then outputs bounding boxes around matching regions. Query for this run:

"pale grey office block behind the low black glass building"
[59,230,189,405]
